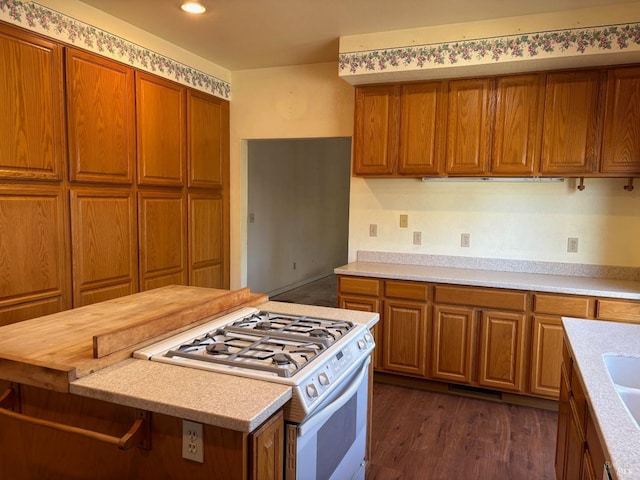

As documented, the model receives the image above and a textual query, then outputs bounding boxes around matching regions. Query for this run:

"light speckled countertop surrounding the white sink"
[562,318,640,480]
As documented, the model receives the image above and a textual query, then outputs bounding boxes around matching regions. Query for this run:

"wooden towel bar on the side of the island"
[0,386,150,450]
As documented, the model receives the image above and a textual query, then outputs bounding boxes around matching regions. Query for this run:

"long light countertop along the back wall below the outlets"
[334,261,640,300]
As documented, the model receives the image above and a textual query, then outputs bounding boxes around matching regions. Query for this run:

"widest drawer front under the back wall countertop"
[434,285,527,312]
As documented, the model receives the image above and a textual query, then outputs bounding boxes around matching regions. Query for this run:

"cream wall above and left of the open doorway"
[231,63,354,289]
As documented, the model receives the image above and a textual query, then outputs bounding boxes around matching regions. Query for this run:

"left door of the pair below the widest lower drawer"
[431,305,476,384]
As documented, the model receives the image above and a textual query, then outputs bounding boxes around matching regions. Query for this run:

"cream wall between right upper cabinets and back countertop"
[349,179,640,267]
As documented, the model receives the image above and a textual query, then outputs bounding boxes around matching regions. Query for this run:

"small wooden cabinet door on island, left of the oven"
[249,410,284,480]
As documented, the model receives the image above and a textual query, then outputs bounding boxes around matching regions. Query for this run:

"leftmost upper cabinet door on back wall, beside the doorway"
[353,85,398,176]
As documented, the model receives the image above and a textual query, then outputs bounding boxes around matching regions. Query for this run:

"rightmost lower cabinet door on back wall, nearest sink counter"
[529,315,564,400]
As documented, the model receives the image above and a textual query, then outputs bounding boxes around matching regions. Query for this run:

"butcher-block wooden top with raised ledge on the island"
[0,285,268,392]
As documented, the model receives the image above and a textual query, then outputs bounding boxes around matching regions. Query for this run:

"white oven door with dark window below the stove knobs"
[285,356,371,480]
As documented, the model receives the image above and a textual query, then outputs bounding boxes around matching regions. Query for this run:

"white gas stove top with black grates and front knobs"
[134,308,374,414]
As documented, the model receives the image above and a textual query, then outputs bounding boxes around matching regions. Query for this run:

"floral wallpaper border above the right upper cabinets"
[338,23,640,75]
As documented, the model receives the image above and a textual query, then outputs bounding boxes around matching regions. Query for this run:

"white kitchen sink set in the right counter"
[604,355,640,428]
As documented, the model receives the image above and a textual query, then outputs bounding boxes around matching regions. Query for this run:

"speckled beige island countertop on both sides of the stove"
[70,302,379,433]
